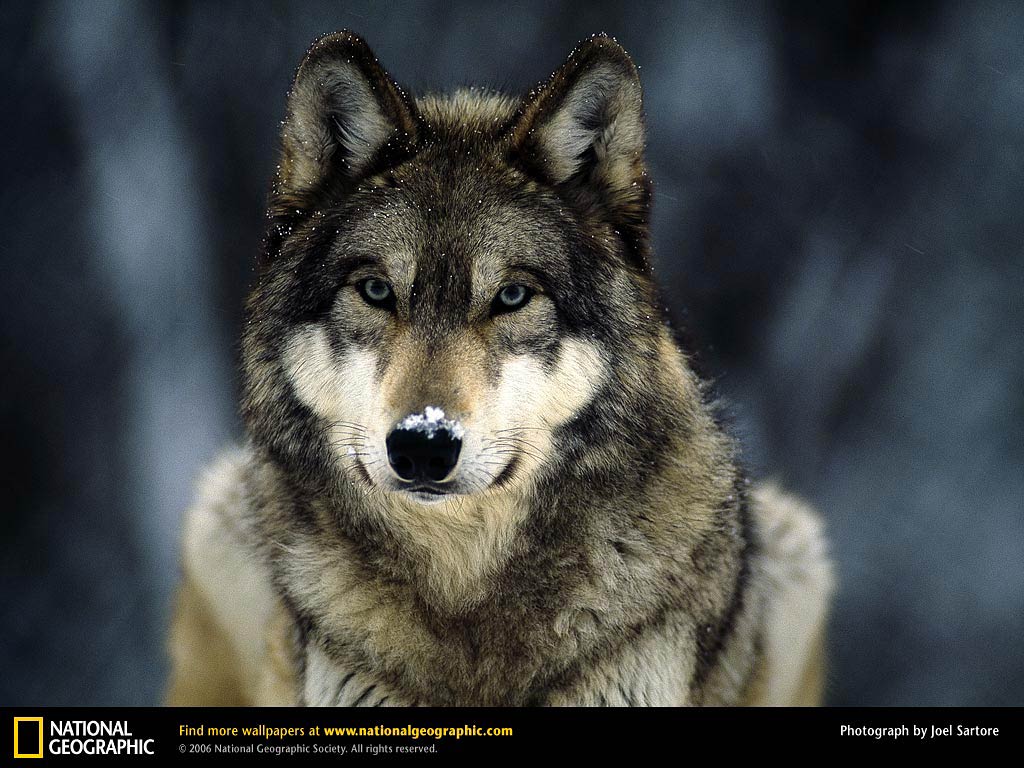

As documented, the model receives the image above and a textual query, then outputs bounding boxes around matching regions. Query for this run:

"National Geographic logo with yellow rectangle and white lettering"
[14,718,156,758]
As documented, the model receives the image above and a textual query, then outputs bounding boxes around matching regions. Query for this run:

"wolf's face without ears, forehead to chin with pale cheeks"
[285,166,605,503]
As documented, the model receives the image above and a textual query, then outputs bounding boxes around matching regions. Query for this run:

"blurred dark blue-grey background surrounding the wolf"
[0,0,1024,705]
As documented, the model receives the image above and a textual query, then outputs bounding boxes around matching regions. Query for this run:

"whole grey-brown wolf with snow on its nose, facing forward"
[161,31,834,707]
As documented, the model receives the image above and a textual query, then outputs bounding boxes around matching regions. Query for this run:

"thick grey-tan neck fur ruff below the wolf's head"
[247,325,739,701]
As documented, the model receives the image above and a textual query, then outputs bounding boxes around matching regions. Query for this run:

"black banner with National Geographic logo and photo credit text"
[0,708,1022,765]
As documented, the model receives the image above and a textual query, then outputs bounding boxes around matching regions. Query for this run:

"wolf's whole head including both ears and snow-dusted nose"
[245,33,660,512]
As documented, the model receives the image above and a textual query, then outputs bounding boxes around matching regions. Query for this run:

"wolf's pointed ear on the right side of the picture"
[512,35,649,233]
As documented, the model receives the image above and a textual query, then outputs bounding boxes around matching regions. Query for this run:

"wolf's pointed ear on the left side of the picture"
[273,31,418,198]
